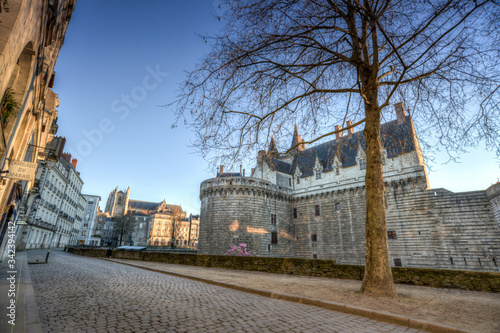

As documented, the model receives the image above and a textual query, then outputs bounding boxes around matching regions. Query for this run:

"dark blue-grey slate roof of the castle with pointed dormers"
[265,117,416,178]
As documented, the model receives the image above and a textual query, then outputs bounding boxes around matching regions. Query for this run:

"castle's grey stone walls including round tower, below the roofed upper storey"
[200,177,500,271]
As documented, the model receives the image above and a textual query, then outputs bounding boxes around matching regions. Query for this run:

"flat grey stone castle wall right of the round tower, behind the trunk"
[292,178,500,271]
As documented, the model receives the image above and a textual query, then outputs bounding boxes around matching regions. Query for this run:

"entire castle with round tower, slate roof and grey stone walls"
[199,103,500,271]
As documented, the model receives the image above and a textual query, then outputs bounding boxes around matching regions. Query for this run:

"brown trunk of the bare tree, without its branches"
[361,85,396,297]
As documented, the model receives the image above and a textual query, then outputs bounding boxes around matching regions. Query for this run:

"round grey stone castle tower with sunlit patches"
[199,177,294,257]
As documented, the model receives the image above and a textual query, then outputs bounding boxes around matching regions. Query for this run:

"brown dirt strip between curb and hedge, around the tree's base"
[115,260,500,333]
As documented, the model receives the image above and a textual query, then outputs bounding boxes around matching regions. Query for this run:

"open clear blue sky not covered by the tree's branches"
[53,0,500,214]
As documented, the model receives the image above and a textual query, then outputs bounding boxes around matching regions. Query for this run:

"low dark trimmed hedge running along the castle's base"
[67,247,500,292]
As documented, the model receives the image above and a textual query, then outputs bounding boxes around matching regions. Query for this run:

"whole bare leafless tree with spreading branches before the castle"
[171,0,500,296]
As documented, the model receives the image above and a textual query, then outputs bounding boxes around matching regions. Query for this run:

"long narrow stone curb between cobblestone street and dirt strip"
[99,258,473,333]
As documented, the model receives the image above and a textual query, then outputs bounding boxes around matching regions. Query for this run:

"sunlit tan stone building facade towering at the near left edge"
[0,0,76,258]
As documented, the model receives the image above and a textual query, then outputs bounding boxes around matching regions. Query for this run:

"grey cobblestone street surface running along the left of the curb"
[28,251,419,333]
